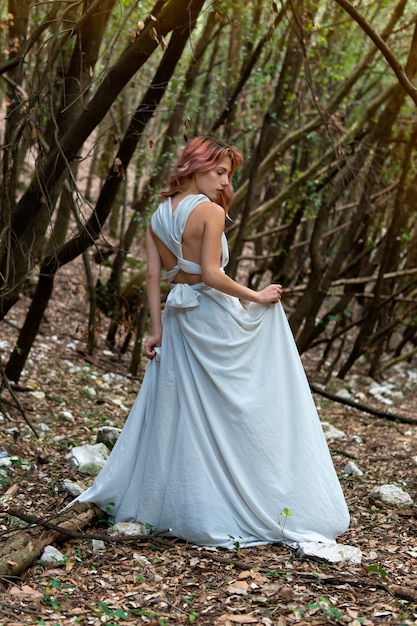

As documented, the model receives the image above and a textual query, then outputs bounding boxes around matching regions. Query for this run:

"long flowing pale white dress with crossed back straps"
[73,195,349,548]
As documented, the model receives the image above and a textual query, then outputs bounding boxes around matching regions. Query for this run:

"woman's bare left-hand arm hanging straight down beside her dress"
[145,227,162,359]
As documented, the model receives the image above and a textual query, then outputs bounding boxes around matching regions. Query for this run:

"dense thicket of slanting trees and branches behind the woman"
[0,0,417,380]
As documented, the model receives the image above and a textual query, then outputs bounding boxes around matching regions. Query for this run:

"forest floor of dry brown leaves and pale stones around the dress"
[0,264,417,626]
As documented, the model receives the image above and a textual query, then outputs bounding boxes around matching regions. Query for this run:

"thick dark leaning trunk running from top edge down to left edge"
[0,0,203,319]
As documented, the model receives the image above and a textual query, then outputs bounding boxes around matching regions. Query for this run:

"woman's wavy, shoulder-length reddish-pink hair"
[161,135,243,210]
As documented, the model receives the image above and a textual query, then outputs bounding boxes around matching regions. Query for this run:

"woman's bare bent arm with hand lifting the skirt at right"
[201,203,282,304]
